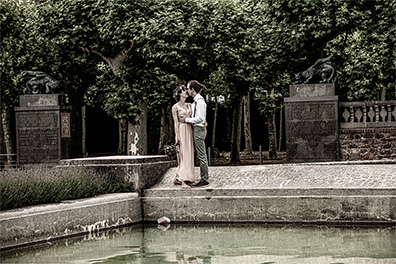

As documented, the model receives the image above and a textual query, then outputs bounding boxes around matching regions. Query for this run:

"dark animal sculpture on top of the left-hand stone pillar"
[22,71,59,94]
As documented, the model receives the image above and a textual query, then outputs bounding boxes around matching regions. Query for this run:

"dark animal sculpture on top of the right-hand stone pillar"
[294,54,335,84]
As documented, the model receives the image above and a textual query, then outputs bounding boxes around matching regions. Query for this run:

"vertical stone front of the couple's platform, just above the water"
[142,195,396,225]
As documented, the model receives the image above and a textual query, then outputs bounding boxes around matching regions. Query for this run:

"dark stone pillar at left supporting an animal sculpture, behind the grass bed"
[15,94,71,165]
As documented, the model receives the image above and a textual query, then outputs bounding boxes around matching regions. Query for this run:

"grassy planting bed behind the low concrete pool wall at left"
[0,167,131,210]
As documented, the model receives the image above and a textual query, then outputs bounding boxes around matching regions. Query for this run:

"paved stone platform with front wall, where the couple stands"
[142,163,396,224]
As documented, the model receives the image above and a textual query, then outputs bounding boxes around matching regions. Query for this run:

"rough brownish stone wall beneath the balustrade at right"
[339,128,396,160]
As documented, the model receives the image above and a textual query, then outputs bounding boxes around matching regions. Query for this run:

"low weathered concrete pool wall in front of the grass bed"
[0,193,142,250]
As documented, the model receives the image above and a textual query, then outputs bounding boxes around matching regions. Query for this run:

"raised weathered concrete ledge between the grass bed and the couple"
[60,155,177,192]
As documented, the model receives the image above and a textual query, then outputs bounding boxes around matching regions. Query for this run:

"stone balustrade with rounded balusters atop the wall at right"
[339,101,396,129]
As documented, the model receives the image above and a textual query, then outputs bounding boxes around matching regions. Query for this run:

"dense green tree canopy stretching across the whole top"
[0,0,396,158]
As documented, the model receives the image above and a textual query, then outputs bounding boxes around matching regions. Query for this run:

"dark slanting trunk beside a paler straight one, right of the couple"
[230,96,243,162]
